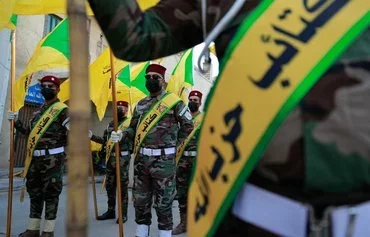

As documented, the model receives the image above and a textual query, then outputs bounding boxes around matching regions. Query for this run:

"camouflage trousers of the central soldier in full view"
[133,152,176,230]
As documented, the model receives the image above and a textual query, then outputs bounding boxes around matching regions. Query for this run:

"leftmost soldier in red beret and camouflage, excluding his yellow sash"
[9,76,69,237]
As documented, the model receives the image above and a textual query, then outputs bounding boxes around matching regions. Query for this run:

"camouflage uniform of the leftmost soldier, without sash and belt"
[15,100,69,220]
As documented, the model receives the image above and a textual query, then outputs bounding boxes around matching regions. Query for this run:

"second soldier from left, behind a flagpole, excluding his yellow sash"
[91,101,132,224]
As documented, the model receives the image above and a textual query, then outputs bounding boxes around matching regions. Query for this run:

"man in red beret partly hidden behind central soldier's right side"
[172,90,203,235]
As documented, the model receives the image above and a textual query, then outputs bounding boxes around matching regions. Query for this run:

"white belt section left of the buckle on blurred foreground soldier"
[232,184,309,237]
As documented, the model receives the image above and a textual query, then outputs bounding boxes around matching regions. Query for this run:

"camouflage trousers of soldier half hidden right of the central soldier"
[176,156,195,215]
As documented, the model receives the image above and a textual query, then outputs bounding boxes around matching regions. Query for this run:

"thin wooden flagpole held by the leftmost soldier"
[6,30,15,237]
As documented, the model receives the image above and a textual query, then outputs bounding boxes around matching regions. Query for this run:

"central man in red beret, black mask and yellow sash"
[111,64,193,237]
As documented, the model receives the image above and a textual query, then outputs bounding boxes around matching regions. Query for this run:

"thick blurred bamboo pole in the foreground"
[66,0,90,237]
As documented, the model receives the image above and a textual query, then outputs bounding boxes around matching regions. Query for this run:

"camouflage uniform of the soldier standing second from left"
[91,121,132,220]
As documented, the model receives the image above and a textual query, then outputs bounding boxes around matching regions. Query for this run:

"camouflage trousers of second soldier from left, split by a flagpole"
[105,155,131,217]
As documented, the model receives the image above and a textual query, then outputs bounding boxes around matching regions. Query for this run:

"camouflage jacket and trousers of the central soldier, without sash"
[123,91,193,230]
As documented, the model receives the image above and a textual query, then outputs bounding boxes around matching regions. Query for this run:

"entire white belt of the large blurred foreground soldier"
[232,184,370,237]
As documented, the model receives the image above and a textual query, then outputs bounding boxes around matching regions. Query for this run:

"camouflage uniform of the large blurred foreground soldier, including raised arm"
[89,0,370,236]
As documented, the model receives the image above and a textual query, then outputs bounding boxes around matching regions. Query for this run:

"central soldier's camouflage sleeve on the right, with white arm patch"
[175,102,194,145]
